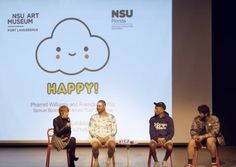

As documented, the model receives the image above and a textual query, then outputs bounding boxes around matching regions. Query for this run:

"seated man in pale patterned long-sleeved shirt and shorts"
[89,100,117,167]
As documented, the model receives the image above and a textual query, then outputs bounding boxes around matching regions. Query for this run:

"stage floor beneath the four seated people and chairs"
[0,146,236,167]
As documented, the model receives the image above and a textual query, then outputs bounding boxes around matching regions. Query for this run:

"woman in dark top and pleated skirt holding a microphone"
[52,106,79,167]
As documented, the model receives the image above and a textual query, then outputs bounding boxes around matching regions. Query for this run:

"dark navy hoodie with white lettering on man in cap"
[149,111,174,141]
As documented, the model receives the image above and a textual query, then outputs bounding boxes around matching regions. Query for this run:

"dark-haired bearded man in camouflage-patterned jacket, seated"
[185,104,223,167]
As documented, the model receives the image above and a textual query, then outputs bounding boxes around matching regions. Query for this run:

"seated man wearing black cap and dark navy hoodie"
[149,102,174,167]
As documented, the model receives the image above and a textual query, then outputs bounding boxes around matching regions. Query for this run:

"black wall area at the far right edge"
[212,0,236,145]
